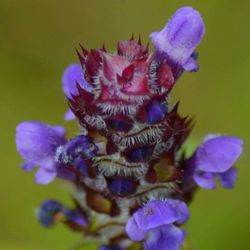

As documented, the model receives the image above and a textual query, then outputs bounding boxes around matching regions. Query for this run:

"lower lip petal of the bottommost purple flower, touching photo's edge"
[144,224,185,250]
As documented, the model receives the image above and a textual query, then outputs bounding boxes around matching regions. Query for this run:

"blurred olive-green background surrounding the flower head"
[0,0,250,250]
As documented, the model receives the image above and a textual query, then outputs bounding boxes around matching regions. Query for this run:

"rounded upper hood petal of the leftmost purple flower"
[16,122,65,164]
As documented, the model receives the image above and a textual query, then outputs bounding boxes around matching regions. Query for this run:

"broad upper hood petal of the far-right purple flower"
[194,136,243,173]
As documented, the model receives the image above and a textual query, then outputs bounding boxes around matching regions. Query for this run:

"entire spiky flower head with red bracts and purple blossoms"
[16,7,243,250]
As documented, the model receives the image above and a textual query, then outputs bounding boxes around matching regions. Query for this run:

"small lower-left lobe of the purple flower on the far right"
[193,171,216,189]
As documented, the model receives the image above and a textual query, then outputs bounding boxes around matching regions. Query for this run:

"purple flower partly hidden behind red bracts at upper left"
[62,64,91,121]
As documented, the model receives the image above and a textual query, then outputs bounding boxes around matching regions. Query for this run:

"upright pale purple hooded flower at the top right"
[150,7,205,71]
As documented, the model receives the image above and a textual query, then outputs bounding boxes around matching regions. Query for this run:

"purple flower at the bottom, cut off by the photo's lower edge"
[126,199,189,250]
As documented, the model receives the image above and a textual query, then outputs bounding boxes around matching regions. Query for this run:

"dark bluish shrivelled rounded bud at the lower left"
[36,200,63,227]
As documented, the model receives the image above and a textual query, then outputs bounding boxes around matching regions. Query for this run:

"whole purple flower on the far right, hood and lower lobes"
[188,135,243,189]
